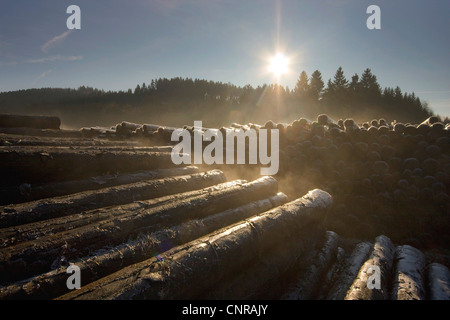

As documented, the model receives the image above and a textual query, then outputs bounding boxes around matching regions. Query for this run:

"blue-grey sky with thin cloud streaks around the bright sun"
[0,0,450,116]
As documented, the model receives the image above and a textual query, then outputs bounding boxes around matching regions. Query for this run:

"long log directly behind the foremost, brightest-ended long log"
[0,193,287,300]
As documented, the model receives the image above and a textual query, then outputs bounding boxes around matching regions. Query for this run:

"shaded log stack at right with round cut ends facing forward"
[175,114,450,249]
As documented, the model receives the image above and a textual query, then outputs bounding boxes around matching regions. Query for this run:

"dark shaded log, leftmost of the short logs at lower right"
[281,231,339,300]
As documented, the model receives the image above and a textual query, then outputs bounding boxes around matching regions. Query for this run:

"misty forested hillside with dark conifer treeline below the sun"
[0,67,442,128]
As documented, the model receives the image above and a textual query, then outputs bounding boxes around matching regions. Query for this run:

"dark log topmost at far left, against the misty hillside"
[0,114,61,129]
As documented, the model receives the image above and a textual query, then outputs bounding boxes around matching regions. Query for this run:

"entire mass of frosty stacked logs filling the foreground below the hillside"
[0,114,450,300]
